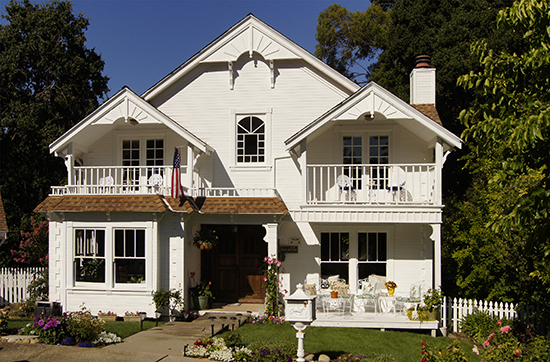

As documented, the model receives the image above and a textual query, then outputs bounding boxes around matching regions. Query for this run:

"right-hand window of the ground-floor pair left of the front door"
[114,229,145,283]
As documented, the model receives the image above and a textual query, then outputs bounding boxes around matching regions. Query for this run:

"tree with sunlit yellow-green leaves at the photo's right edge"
[459,0,550,307]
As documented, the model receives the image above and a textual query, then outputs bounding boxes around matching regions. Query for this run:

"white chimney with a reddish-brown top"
[410,55,435,106]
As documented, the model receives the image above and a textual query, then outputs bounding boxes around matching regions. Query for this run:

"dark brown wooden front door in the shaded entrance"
[201,225,267,303]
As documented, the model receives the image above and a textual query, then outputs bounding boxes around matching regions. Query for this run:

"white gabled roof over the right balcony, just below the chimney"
[285,82,462,151]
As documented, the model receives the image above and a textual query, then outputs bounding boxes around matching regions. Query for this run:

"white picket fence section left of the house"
[0,268,44,307]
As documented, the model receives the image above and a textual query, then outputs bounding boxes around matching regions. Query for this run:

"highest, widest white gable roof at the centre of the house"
[142,14,359,102]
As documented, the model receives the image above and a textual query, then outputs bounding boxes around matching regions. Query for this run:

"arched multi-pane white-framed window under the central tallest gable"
[237,116,265,163]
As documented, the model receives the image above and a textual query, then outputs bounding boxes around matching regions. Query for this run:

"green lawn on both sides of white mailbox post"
[221,323,476,362]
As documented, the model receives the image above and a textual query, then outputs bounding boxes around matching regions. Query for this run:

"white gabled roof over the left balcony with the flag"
[50,87,213,155]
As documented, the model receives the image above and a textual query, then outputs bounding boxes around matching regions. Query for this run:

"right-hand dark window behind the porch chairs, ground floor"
[357,232,388,279]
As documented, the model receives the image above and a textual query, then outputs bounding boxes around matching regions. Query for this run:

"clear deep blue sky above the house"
[0,0,370,96]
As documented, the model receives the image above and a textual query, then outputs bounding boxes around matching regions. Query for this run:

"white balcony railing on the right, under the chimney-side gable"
[306,164,438,205]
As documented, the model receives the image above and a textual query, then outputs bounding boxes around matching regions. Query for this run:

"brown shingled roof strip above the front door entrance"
[166,197,288,215]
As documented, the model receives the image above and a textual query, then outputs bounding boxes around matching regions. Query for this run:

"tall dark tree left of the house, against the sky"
[0,0,108,266]
